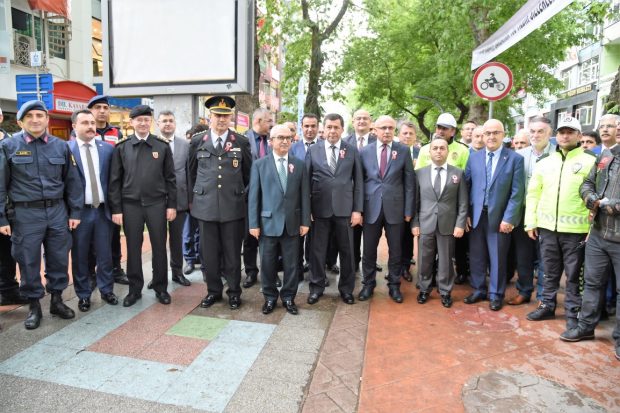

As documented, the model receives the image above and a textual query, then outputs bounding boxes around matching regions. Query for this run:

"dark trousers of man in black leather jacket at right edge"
[579,231,620,346]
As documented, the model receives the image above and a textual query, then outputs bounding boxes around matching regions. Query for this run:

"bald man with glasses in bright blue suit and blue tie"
[464,119,524,311]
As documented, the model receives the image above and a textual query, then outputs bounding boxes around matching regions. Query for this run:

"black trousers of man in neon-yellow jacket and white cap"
[539,228,587,318]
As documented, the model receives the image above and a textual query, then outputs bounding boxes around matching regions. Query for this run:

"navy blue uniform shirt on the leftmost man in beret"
[0,132,84,226]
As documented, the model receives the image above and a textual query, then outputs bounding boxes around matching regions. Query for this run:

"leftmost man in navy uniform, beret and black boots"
[0,100,84,330]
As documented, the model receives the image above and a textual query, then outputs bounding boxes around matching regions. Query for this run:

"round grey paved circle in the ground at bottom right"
[463,371,607,413]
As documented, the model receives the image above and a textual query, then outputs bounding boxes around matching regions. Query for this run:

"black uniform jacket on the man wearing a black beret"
[108,134,177,214]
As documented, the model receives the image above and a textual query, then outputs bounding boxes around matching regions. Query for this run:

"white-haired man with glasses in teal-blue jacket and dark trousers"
[248,125,310,315]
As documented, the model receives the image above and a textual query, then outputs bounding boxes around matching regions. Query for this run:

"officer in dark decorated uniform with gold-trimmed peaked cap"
[189,96,252,310]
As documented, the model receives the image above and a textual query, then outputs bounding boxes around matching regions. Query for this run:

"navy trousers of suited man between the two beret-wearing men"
[71,204,114,298]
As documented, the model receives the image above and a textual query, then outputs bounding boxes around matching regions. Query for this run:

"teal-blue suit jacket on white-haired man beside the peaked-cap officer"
[248,153,310,237]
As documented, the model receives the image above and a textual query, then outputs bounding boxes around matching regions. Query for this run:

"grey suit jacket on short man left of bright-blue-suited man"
[411,164,469,235]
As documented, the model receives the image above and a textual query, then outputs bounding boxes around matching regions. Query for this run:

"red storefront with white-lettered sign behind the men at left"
[48,80,97,140]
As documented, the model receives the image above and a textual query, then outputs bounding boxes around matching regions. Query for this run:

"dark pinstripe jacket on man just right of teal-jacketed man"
[306,141,364,218]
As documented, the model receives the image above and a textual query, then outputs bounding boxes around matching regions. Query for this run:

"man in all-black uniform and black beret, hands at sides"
[108,105,177,307]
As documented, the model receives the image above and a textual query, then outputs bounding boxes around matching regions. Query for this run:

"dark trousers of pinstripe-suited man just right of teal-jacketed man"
[310,216,355,294]
